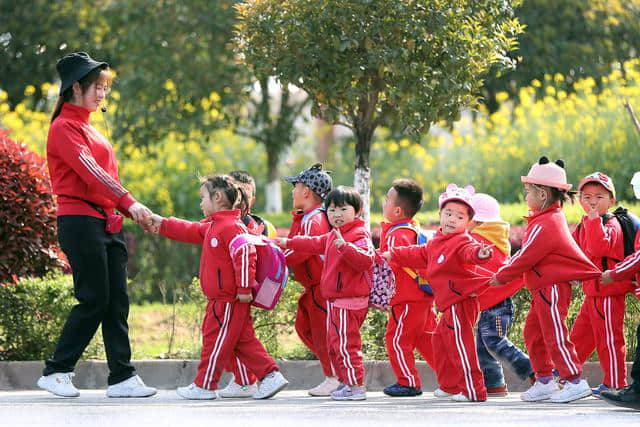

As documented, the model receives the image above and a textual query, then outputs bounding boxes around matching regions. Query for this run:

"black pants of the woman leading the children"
[43,215,135,385]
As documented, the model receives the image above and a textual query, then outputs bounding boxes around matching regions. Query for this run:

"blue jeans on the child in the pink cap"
[476,298,533,388]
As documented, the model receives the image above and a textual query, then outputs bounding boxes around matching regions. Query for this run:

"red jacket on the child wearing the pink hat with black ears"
[496,203,601,292]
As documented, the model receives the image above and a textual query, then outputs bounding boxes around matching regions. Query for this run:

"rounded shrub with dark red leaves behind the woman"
[0,129,62,283]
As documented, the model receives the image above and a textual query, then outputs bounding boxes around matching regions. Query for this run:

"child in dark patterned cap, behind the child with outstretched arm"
[284,163,340,396]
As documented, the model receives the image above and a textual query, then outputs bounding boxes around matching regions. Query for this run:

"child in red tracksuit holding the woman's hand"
[152,175,288,399]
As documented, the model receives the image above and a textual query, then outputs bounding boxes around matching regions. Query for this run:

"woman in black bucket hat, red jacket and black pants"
[38,52,156,397]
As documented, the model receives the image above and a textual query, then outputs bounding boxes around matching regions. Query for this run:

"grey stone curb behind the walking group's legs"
[0,360,631,392]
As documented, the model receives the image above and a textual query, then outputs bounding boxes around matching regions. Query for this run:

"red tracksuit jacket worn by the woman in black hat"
[47,102,136,218]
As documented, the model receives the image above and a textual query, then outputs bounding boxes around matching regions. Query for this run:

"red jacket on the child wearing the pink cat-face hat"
[390,229,491,312]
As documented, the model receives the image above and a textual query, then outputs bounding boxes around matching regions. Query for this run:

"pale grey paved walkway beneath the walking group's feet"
[0,390,640,427]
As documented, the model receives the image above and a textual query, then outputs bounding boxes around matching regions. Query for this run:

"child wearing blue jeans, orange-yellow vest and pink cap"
[469,193,535,397]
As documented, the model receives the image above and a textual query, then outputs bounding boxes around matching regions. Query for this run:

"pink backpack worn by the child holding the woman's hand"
[229,234,289,310]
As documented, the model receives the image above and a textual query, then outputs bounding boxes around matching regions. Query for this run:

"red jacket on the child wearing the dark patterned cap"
[284,205,331,288]
